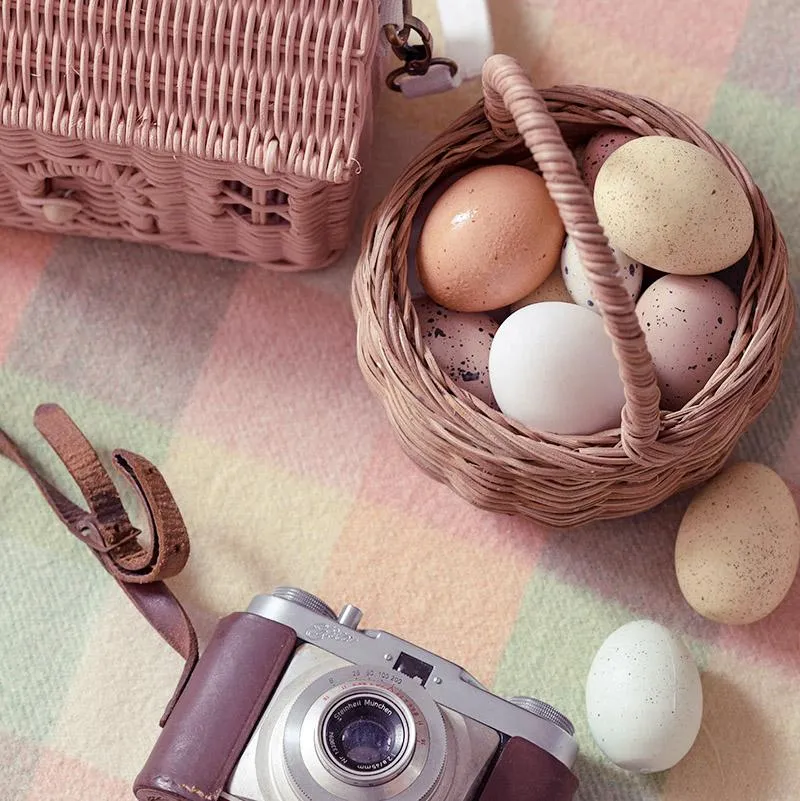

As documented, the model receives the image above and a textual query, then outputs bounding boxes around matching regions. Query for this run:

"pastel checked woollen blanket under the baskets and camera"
[0,0,800,801]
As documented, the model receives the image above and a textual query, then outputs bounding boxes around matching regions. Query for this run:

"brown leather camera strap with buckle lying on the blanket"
[0,404,197,725]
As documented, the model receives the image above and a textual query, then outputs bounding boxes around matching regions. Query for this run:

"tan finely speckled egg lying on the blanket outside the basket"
[675,462,800,624]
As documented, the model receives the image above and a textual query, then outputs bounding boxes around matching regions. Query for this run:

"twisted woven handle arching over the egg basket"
[483,55,661,461]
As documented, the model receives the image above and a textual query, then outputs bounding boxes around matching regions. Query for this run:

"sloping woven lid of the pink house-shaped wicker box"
[0,0,378,183]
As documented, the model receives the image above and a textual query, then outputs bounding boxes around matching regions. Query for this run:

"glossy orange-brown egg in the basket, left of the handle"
[417,165,564,312]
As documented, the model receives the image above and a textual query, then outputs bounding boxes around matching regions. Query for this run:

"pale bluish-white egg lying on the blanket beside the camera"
[586,620,703,773]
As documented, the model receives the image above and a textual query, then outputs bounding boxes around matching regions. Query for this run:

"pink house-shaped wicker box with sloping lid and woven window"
[0,0,380,270]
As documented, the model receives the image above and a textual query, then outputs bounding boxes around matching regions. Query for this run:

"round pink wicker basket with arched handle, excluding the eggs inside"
[352,56,794,527]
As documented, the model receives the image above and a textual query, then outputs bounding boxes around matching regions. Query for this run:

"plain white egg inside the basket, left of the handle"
[489,302,625,435]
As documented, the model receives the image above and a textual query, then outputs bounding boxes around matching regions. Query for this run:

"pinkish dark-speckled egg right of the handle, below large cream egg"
[636,275,739,410]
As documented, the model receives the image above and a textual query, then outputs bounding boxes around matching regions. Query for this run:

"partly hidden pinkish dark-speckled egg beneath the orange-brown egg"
[414,298,498,406]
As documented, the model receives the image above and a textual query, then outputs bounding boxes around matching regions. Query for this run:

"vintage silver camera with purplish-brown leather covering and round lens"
[134,587,577,801]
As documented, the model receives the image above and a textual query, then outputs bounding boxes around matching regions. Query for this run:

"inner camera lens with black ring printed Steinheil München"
[322,691,410,775]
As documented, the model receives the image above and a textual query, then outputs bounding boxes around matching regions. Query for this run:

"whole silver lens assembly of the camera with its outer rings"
[278,668,448,801]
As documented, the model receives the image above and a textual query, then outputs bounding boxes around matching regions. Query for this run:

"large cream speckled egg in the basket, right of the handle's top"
[594,136,754,275]
